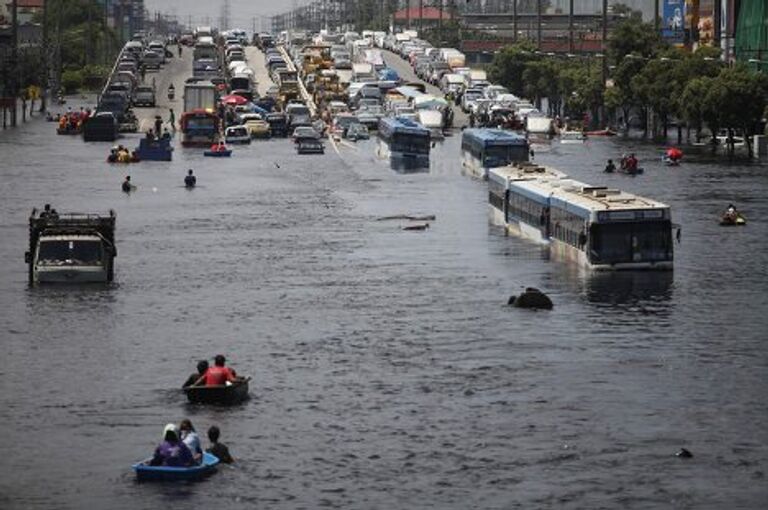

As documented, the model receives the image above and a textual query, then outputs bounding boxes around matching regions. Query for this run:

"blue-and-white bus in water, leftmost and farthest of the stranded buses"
[377,117,431,170]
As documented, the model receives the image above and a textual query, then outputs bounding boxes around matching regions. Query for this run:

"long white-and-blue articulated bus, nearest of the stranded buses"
[488,163,673,271]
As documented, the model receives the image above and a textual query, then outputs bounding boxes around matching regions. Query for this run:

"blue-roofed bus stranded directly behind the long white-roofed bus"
[461,128,529,180]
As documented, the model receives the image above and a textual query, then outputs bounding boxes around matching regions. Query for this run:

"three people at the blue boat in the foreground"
[149,419,234,467]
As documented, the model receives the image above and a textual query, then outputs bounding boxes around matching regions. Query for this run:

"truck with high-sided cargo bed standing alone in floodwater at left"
[24,206,117,285]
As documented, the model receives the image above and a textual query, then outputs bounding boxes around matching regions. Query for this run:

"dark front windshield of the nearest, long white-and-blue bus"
[590,221,672,264]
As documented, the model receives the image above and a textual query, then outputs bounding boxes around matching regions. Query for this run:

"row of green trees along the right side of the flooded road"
[489,19,768,151]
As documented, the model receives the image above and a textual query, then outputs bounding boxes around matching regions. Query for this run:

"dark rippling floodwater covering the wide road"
[0,60,768,510]
